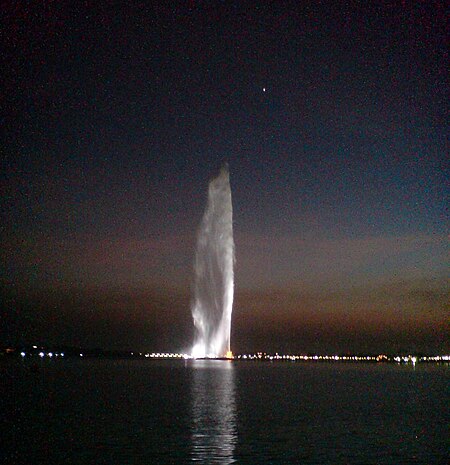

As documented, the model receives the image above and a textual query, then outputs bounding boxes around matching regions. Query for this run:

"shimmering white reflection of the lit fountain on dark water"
[192,360,237,465]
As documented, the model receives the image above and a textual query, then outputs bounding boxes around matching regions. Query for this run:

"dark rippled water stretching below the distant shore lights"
[4,359,450,465]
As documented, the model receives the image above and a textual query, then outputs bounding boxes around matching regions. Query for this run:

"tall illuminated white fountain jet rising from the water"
[192,165,234,358]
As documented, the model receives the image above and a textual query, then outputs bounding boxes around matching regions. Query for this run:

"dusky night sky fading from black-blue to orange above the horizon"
[0,0,450,352]
